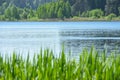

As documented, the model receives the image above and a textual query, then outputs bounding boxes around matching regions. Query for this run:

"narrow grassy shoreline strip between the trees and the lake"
[0,17,120,22]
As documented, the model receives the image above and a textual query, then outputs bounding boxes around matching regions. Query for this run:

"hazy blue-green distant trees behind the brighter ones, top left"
[0,0,56,9]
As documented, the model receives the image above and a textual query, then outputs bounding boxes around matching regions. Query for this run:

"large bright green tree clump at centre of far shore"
[37,1,71,19]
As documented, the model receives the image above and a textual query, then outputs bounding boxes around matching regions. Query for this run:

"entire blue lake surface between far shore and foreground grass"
[0,22,120,58]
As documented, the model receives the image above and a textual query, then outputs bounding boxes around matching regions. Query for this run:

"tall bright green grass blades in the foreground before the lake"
[0,47,120,80]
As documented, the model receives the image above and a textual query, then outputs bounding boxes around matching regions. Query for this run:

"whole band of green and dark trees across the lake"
[0,0,120,21]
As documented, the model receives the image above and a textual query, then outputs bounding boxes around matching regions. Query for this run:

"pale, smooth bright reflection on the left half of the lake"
[0,23,59,57]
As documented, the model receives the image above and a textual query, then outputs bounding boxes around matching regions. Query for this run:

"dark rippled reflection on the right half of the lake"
[59,29,120,58]
